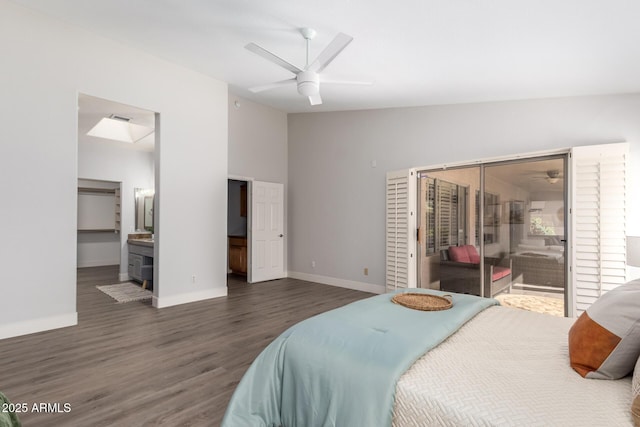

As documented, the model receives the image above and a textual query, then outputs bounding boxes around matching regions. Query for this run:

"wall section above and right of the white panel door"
[229,94,289,270]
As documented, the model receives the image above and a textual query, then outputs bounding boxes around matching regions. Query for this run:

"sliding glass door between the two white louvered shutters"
[418,155,568,316]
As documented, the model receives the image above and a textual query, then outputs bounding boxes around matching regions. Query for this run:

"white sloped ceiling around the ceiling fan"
[14,0,640,112]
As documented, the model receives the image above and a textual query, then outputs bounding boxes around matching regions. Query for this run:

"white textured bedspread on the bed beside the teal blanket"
[393,307,632,427]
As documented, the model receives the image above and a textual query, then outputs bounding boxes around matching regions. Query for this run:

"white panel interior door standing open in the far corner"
[251,181,284,283]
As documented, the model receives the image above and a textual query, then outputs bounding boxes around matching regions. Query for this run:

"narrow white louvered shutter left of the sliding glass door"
[386,170,416,291]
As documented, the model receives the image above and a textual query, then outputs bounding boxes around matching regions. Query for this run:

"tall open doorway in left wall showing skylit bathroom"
[77,94,159,308]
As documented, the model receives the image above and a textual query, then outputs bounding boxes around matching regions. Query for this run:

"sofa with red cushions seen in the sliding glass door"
[440,245,512,297]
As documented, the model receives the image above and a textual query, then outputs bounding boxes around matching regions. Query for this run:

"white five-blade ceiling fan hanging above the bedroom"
[245,28,373,105]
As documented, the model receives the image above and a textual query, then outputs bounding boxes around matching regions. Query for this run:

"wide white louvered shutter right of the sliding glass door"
[569,143,629,316]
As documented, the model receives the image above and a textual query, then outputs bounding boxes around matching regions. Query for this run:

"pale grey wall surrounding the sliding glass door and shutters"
[289,94,640,291]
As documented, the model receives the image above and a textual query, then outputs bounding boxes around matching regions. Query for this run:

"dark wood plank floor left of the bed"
[0,266,371,427]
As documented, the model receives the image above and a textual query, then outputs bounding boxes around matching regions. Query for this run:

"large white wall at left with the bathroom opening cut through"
[0,0,228,338]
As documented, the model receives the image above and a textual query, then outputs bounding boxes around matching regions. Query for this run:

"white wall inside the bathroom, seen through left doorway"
[78,134,155,272]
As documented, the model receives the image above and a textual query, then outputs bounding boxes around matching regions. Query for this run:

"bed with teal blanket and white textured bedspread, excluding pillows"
[222,289,633,427]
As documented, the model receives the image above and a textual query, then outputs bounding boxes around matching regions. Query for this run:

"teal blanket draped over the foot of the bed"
[222,289,498,427]
